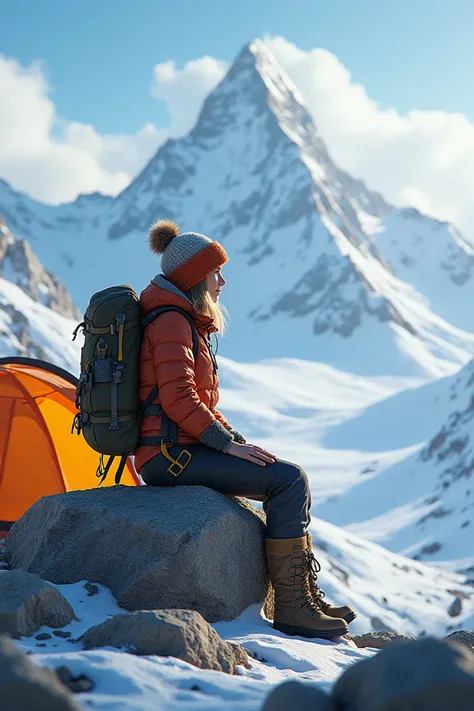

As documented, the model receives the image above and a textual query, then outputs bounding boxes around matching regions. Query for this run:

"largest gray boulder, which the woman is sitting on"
[7,486,268,622]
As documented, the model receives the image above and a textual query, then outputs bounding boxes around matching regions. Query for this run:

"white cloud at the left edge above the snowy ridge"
[0,55,167,203]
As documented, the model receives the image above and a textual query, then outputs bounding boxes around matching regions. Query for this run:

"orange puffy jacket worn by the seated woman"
[135,275,232,472]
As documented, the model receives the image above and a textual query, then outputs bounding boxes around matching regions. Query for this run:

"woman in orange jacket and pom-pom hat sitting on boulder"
[135,220,356,638]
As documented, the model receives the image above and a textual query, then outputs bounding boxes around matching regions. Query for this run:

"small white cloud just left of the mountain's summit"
[151,57,228,136]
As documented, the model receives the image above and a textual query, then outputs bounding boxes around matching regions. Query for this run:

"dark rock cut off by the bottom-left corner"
[0,635,81,711]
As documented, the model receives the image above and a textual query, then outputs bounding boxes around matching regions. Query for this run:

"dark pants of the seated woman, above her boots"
[140,444,311,538]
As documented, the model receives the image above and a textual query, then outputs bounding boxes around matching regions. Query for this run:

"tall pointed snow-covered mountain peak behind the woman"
[0,41,474,377]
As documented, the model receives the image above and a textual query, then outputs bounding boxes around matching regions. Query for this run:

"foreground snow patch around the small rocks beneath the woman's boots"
[0,572,372,711]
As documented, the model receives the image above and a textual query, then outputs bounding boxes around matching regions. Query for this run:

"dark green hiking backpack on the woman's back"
[71,286,198,485]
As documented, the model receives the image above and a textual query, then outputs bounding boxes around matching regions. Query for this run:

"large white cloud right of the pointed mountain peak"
[265,37,474,239]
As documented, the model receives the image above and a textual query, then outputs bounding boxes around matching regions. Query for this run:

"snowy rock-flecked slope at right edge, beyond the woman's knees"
[316,361,474,580]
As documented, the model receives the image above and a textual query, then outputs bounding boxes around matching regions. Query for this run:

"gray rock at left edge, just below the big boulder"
[0,570,74,637]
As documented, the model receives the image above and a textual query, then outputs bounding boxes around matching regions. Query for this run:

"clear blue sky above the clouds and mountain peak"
[0,0,474,132]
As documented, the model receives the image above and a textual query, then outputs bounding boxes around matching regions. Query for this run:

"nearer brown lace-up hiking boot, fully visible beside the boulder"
[265,536,349,639]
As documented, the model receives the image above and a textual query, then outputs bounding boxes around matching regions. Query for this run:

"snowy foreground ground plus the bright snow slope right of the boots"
[0,508,474,711]
